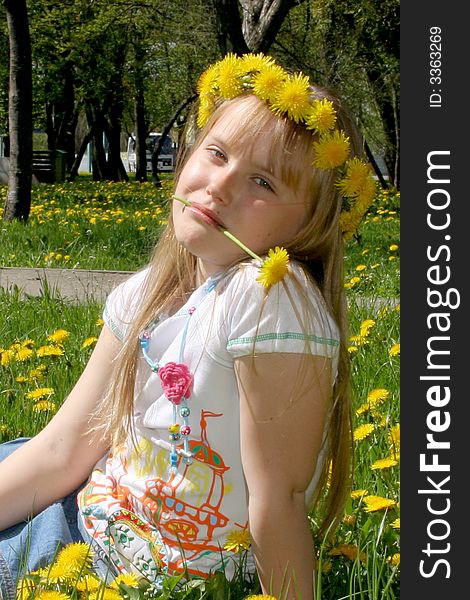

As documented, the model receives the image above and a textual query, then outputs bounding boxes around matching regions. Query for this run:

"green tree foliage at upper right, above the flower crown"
[272,0,400,177]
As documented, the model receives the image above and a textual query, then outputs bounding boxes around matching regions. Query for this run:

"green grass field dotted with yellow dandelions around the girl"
[0,181,400,600]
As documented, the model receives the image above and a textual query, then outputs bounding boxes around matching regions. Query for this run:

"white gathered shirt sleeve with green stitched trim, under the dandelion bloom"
[222,264,339,363]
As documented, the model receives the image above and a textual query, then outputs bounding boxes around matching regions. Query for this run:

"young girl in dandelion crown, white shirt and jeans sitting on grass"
[0,55,373,600]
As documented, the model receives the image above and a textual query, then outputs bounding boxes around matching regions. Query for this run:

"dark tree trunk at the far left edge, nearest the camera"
[3,0,33,221]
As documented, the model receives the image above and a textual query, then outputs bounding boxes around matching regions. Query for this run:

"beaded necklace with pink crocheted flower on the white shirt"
[139,276,220,473]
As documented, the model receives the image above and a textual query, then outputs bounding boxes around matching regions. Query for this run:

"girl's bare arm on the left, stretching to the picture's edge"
[0,325,121,530]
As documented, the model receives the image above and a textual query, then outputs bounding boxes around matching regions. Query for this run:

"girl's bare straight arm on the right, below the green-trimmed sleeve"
[235,354,331,600]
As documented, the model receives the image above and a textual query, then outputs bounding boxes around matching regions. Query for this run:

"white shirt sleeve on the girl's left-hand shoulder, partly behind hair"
[103,269,148,341]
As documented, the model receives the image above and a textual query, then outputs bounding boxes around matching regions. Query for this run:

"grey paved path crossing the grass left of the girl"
[0,267,132,302]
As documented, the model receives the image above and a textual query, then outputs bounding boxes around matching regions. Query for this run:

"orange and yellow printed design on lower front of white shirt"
[81,411,237,578]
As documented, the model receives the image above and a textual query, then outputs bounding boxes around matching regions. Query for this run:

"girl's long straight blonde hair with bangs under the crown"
[95,87,361,535]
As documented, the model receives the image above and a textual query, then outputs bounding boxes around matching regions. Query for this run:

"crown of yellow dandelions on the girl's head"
[197,54,376,240]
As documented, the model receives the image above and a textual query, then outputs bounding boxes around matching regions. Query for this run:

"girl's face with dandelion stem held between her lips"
[173,102,308,276]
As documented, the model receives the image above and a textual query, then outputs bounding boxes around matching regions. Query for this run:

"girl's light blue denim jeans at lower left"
[0,438,83,600]
